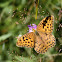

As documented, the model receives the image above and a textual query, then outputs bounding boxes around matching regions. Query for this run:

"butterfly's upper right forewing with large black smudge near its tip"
[37,16,54,33]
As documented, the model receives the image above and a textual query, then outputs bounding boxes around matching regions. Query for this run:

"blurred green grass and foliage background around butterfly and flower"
[0,0,62,62]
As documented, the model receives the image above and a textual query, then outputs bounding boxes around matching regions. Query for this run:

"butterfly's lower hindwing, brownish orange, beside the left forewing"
[34,36,48,54]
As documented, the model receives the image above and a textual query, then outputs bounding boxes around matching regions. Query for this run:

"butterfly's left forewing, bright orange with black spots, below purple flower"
[16,32,35,48]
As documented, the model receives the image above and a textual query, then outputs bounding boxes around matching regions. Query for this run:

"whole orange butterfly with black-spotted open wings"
[16,15,56,54]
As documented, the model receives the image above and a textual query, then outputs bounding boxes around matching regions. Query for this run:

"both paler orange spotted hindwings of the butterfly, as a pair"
[34,32,56,54]
